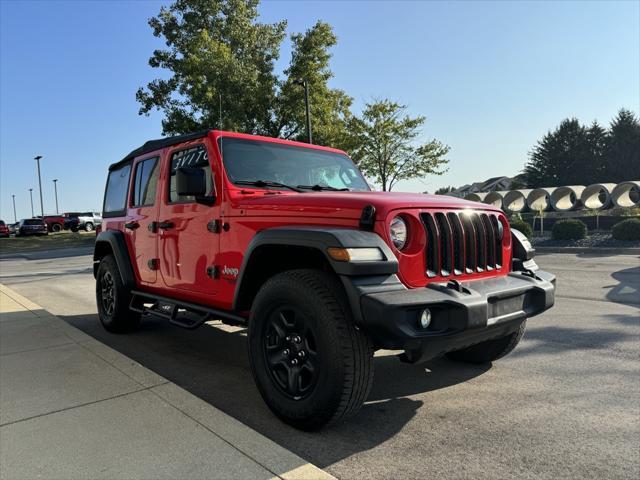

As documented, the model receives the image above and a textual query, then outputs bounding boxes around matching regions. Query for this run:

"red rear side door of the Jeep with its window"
[124,155,160,285]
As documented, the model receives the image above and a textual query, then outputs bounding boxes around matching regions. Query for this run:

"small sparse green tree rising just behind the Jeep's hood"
[351,99,449,192]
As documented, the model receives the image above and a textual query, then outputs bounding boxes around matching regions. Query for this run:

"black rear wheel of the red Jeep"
[96,255,140,333]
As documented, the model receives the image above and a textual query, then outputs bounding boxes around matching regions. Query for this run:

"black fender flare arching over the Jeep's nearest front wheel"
[233,226,398,310]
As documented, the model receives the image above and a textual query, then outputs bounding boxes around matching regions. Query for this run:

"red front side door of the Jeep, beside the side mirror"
[158,142,220,299]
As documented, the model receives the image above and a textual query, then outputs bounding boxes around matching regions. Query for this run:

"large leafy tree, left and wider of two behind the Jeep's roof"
[136,0,286,134]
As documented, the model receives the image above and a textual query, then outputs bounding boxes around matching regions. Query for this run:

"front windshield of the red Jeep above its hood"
[220,138,370,191]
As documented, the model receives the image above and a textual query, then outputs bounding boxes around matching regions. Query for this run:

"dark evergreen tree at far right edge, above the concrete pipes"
[603,109,640,182]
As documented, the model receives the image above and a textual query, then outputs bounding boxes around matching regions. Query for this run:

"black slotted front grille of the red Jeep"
[420,211,502,278]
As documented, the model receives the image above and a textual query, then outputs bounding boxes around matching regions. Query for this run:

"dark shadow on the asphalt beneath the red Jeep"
[61,315,490,468]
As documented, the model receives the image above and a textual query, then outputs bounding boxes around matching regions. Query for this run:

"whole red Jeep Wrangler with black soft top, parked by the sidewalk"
[94,130,555,430]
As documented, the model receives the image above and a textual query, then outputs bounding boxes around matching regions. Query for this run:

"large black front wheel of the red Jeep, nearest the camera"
[249,270,373,430]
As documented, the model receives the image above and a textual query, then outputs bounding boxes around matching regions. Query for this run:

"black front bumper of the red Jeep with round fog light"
[346,270,555,358]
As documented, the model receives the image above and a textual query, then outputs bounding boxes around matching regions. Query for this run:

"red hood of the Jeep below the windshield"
[230,191,499,219]
